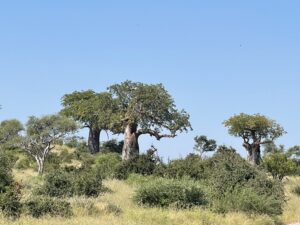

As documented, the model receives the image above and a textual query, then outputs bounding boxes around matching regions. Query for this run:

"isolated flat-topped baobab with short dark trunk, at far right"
[223,113,285,165]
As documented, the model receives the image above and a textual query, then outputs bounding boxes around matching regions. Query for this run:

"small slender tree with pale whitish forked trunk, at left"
[20,115,77,175]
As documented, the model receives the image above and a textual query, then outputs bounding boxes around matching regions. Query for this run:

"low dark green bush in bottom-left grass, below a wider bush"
[25,197,73,218]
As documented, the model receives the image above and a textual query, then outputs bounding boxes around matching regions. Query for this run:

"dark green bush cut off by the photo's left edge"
[0,152,21,217]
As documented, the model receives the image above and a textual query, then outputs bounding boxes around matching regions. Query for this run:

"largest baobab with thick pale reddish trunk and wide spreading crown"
[108,81,191,160]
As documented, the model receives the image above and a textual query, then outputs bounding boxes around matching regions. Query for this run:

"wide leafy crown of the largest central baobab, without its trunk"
[108,81,191,134]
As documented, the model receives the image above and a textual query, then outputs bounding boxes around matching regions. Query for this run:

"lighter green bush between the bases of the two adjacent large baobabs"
[96,153,122,179]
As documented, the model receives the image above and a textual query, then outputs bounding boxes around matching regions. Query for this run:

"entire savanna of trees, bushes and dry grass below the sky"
[0,81,300,225]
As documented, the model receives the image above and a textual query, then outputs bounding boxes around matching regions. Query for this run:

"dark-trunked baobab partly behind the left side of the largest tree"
[61,90,116,154]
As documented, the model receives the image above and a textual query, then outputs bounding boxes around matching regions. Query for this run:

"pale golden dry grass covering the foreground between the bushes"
[0,171,300,225]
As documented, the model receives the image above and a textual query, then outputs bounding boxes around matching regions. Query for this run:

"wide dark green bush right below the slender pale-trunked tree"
[38,169,102,197]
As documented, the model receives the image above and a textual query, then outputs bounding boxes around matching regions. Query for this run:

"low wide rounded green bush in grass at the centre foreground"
[134,178,206,208]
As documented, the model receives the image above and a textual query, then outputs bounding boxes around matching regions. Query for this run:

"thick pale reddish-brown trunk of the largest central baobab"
[122,124,139,160]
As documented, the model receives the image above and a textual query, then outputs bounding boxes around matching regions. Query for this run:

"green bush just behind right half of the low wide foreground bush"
[163,154,205,180]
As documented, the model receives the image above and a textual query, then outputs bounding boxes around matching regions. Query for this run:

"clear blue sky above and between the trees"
[0,0,300,159]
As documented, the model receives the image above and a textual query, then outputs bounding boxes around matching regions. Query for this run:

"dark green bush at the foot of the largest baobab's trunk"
[115,153,161,179]
